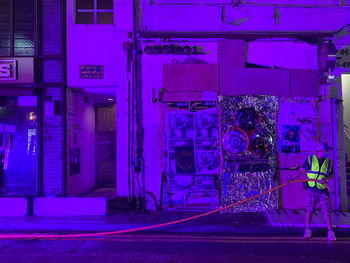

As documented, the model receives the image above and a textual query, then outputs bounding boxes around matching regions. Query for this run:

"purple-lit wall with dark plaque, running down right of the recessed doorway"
[67,0,133,201]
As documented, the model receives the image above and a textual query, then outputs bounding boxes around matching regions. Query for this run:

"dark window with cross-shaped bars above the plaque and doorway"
[75,0,114,24]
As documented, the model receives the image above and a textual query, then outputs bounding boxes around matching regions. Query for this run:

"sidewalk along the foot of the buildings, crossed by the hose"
[0,210,350,236]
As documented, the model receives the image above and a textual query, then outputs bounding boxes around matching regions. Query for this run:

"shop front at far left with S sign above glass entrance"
[0,58,40,197]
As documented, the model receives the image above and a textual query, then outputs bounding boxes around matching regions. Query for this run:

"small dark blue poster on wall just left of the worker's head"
[281,125,301,153]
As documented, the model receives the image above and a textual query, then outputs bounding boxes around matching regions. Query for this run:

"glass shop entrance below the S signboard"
[0,96,38,197]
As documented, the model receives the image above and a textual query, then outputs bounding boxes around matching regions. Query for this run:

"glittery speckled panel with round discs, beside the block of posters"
[220,96,278,212]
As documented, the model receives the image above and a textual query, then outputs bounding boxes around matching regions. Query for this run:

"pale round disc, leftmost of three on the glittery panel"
[222,129,249,154]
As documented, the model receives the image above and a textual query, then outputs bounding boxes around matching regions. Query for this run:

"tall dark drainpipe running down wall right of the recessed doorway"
[133,0,146,210]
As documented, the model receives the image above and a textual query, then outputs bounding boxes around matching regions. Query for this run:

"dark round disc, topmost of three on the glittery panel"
[235,108,260,131]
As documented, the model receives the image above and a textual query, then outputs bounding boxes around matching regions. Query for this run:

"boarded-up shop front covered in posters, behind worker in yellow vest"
[142,39,344,212]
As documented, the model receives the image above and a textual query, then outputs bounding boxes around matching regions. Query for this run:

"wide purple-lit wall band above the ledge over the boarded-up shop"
[142,0,349,32]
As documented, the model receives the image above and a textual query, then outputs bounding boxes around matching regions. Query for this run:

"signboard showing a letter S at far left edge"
[0,57,34,83]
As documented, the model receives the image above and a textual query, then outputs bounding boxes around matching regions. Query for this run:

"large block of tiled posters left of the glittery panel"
[164,108,220,209]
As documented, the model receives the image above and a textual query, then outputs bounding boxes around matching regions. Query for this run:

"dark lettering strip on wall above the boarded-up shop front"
[143,44,208,56]
